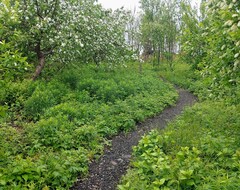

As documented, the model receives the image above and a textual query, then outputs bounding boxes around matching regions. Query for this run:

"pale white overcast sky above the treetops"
[98,0,201,10]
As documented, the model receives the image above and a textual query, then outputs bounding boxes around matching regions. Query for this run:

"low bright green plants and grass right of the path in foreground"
[118,102,240,190]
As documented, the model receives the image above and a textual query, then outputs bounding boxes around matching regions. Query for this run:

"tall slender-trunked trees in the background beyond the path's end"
[140,0,179,67]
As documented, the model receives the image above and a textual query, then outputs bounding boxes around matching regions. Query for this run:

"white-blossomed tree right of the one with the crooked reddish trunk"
[76,5,129,65]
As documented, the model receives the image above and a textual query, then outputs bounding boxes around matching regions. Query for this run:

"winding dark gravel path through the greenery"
[72,89,196,190]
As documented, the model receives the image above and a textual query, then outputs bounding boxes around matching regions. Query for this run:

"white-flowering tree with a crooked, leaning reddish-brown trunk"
[19,0,91,79]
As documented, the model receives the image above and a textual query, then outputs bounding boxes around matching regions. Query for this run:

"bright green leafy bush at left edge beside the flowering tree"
[0,0,29,81]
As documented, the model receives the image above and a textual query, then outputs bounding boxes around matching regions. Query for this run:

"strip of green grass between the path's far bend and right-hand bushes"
[159,62,240,104]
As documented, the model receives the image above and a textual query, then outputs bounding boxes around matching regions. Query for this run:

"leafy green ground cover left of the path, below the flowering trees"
[0,65,178,190]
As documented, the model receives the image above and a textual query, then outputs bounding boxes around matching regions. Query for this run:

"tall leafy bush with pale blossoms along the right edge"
[183,0,240,104]
